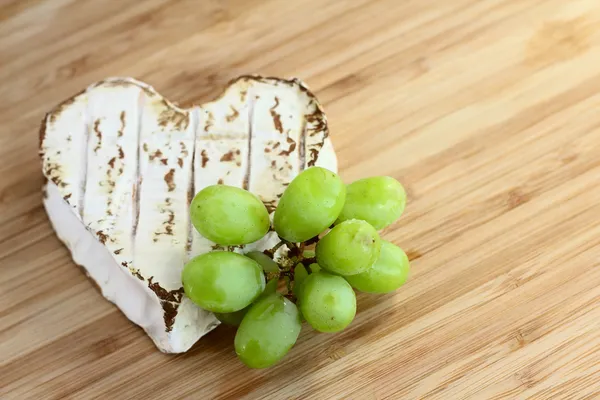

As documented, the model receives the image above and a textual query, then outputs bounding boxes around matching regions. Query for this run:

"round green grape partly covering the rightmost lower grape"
[317,219,381,275]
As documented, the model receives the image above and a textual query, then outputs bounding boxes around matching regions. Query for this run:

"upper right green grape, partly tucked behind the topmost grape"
[336,176,406,230]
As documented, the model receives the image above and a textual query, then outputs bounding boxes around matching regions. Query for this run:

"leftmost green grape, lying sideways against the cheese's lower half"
[181,251,265,313]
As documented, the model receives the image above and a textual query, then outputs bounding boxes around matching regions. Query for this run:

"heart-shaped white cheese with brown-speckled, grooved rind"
[40,76,337,352]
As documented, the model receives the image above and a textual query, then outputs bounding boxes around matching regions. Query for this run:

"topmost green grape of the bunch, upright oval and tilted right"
[273,167,346,242]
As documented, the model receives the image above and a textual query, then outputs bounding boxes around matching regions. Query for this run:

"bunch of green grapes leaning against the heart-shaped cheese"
[182,167,409,368]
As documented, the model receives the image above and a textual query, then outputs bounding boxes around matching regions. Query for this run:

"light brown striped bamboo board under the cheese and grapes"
[0,0,600,400]
